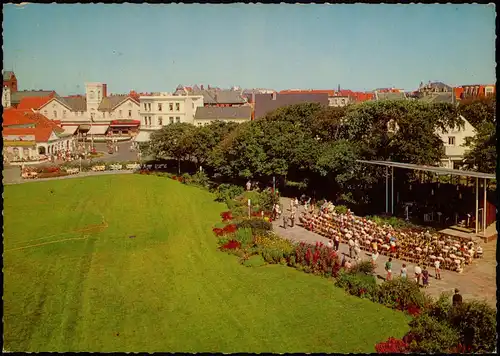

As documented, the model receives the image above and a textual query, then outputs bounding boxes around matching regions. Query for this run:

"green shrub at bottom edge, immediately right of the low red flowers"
[403,314,459,353]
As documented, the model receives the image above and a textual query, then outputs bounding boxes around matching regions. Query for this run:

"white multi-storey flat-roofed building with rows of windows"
[136,93,203,142]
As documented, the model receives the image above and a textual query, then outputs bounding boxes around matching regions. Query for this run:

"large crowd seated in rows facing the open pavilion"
[299,202,482,272]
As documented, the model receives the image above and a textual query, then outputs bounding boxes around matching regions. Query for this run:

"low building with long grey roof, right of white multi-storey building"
[194,106,252,126]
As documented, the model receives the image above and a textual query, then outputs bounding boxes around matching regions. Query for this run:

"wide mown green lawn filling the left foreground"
[3,175,408,353]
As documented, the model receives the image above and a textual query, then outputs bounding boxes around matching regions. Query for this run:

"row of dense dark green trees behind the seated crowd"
[143,100,496,209]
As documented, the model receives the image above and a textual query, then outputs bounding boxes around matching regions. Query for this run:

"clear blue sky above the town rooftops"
[3,4,496,95]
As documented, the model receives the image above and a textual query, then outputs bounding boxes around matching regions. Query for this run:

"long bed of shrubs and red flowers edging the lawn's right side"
[213,207,496,353]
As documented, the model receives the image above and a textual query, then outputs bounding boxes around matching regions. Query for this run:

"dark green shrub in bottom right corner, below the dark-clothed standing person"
[449,301,497,353]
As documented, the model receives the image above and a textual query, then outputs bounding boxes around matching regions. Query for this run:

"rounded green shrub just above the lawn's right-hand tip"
[378,278,431,314]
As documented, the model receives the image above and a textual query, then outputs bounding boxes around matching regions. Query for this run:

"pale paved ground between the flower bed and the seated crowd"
[273,198,496,308]
